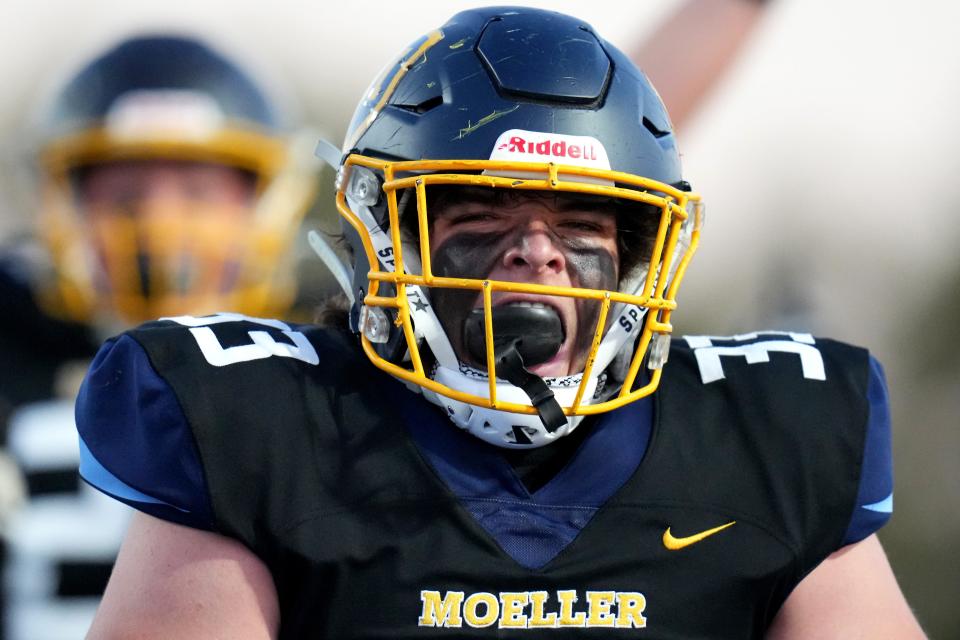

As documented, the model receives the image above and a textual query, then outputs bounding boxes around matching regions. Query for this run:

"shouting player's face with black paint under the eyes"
[430,189,620,377]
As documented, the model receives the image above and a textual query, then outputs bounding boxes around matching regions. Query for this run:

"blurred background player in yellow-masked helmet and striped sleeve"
[0,35,318,640]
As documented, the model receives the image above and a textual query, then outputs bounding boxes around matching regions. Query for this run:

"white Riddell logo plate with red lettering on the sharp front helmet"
[490,129,610,169]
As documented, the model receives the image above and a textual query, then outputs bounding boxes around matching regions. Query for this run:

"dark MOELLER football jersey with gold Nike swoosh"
[77,314,892,638]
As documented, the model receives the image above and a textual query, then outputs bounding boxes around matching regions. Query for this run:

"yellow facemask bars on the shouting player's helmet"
[337,155,703,416]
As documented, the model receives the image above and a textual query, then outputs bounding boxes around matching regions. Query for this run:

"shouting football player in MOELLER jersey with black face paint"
[77,7,922,638]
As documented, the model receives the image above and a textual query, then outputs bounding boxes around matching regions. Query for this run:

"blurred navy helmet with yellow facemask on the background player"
[39,35,318,325]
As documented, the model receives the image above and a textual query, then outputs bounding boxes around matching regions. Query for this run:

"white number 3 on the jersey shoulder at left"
[161,313,320,367]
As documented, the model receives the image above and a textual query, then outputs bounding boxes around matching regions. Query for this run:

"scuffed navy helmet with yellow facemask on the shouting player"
[337,7,703,448]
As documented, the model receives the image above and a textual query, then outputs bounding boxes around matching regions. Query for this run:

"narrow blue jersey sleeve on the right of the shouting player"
[841,356,893,546]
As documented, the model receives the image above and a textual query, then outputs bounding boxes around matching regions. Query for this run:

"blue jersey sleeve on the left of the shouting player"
[76,334,214,530]
